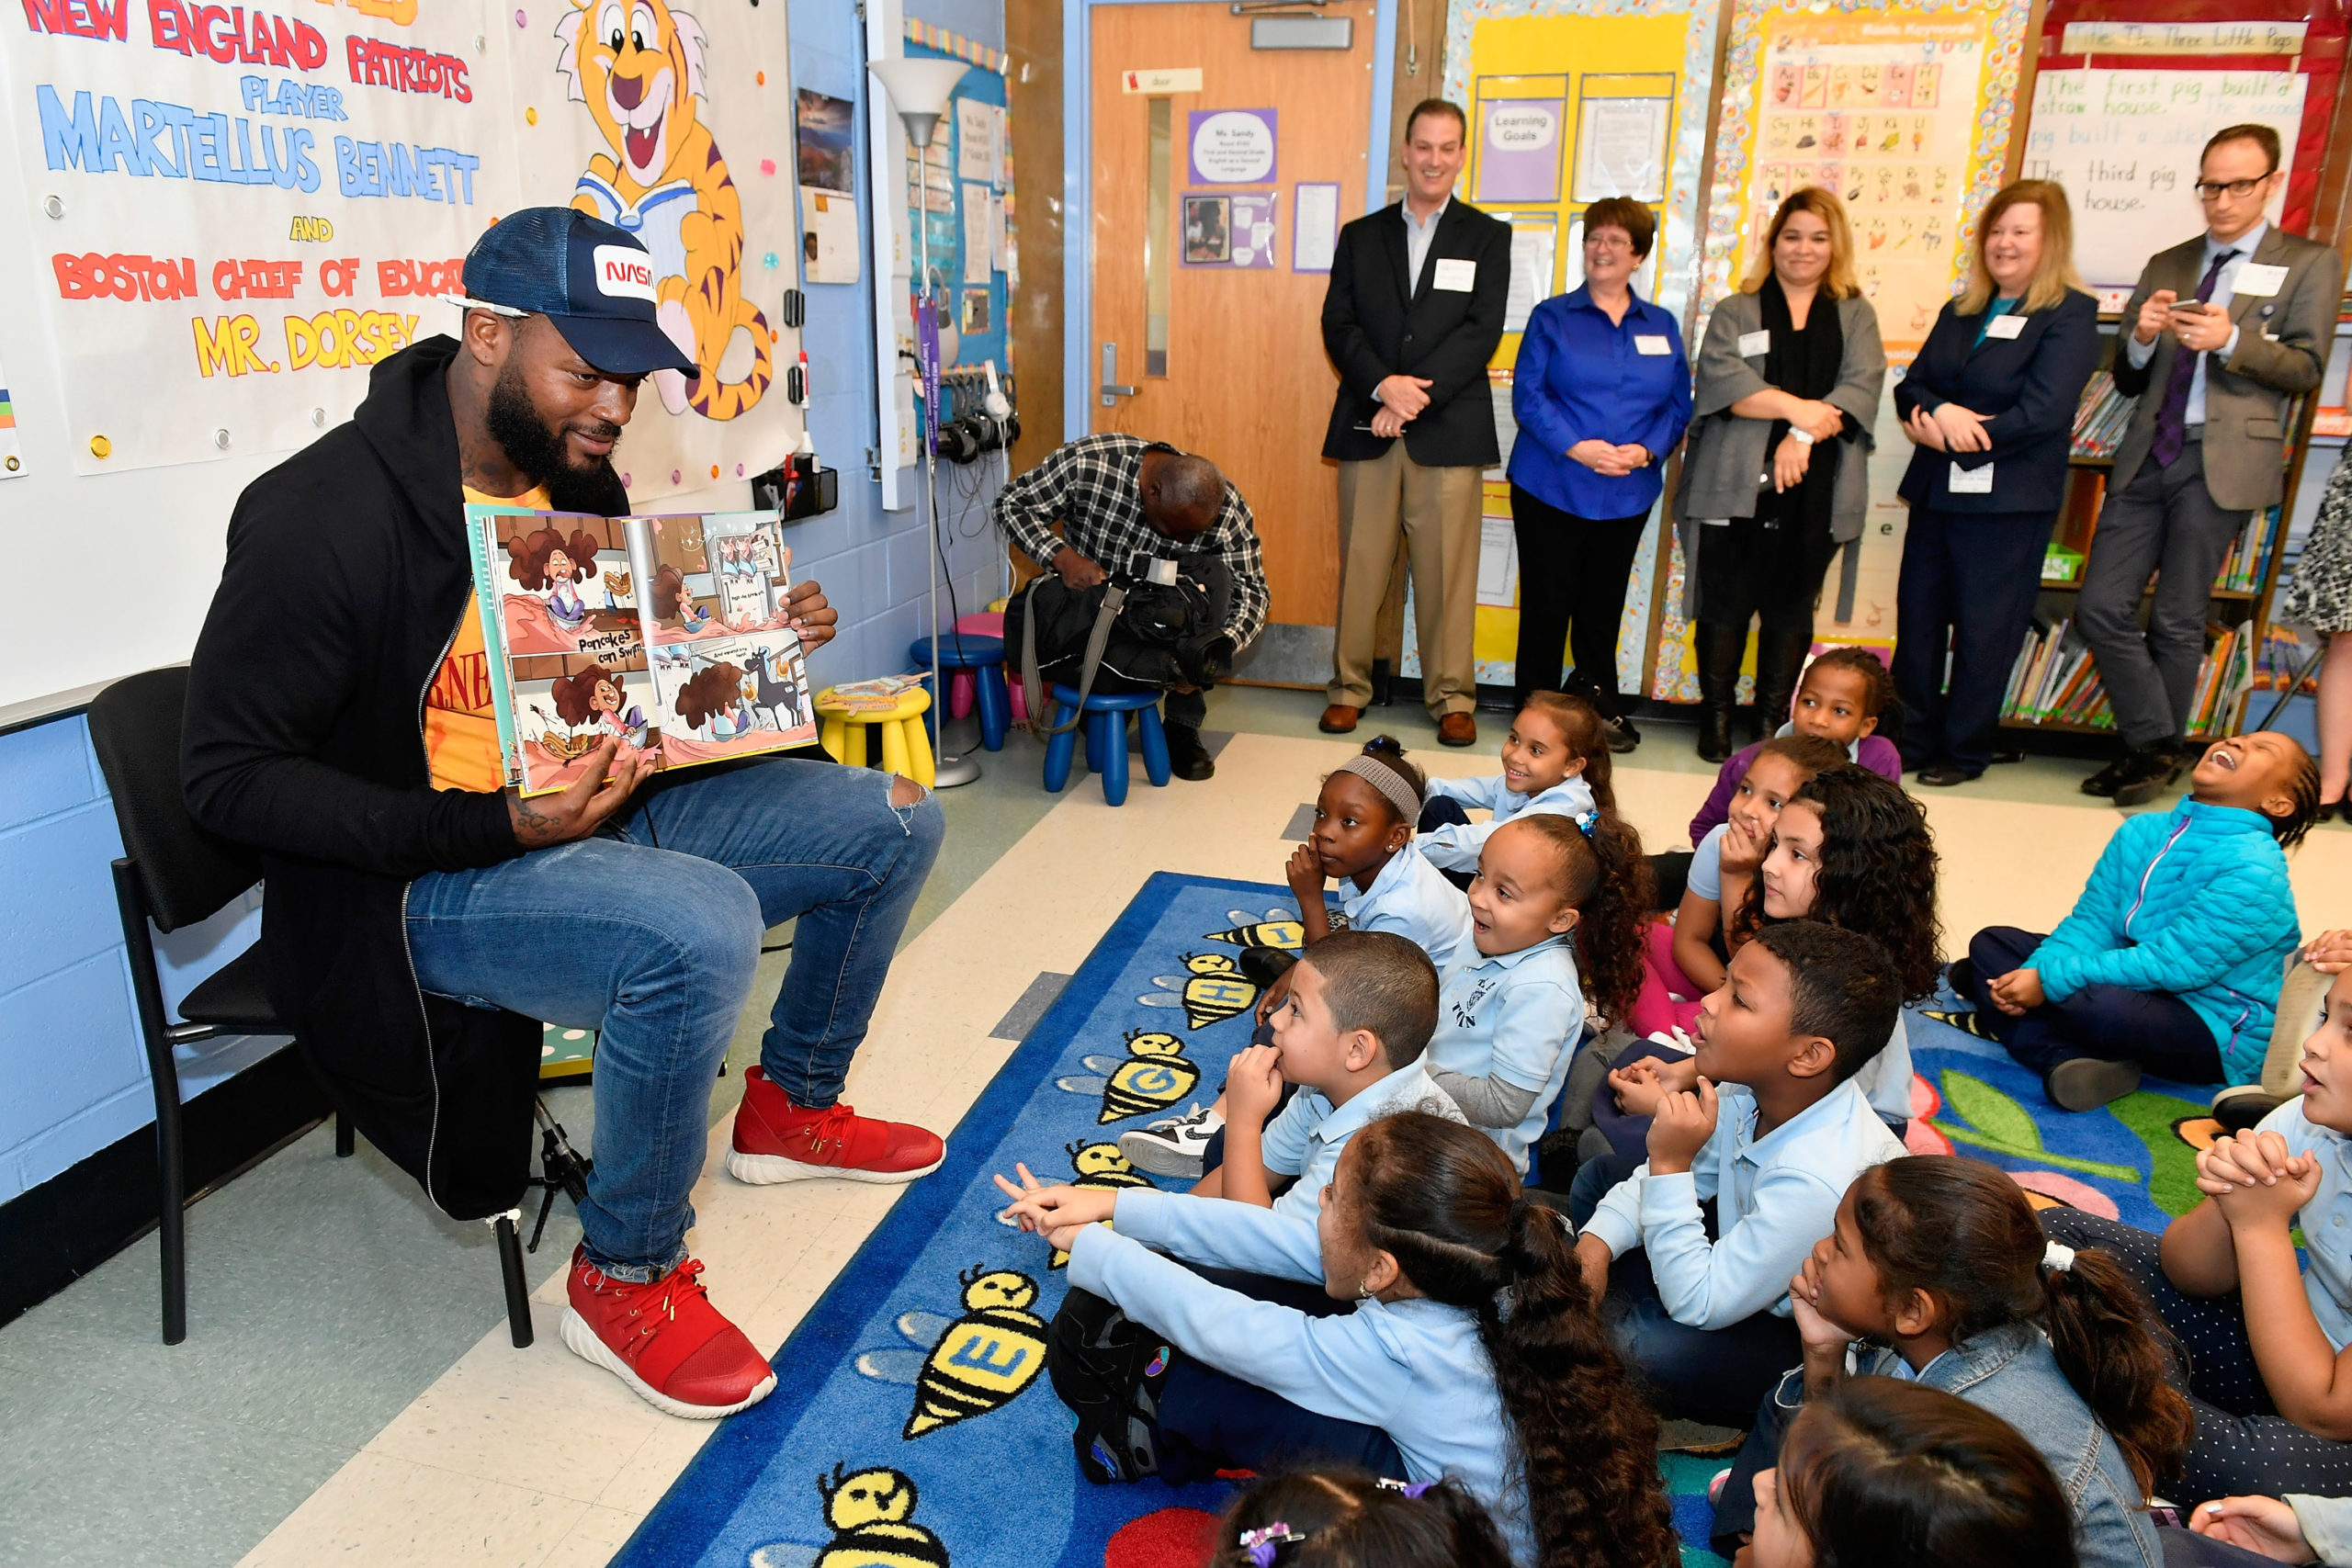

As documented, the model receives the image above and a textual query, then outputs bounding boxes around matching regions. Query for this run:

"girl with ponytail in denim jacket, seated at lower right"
[1714,1155,2192,1568]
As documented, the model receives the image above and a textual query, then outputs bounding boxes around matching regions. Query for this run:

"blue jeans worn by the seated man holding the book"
[407,757,945,1281]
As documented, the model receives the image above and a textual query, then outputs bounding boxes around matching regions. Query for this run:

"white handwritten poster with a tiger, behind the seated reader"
[0,0,814,484]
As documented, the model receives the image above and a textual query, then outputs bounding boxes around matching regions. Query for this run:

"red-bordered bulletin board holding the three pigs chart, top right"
[2023,0,2345,290]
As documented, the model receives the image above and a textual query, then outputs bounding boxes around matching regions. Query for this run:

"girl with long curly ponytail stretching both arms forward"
[997,1112,1677,1568]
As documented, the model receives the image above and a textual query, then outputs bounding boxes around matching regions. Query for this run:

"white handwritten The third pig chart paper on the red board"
[2023,66,2310,289]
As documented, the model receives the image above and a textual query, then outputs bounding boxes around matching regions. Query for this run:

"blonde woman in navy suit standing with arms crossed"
[1894,179,2098,785]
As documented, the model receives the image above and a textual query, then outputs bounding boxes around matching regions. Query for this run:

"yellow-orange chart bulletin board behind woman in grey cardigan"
[1649,0,2032,703]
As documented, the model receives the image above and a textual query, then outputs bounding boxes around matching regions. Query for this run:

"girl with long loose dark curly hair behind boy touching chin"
[1595,761,1943,1159]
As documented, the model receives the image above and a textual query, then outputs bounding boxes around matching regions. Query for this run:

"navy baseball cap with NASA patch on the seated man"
[458,207,698,378]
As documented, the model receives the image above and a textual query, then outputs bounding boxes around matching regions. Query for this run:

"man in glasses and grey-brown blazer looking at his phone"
[2076,125,2343,807]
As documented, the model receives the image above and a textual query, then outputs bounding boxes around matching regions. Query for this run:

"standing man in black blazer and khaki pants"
[1322,98,1510,745]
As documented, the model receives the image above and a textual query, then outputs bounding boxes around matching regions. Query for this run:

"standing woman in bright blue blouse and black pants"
[1510,195,1691,752]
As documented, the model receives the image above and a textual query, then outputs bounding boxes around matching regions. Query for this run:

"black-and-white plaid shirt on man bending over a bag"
[995,433,1272,647]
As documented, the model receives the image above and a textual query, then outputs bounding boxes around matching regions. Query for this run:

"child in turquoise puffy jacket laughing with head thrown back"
[1952,731,2319,1110]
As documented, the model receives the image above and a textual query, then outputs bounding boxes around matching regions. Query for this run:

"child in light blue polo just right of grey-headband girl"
[1423,813,1600,1176]
